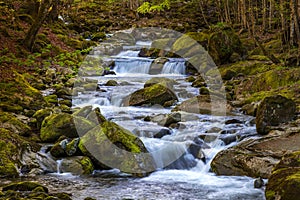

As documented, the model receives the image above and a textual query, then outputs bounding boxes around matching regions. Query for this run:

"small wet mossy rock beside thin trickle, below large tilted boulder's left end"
[59,156,94,175]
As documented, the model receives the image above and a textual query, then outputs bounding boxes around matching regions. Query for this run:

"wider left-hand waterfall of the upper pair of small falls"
[114,58,153,74]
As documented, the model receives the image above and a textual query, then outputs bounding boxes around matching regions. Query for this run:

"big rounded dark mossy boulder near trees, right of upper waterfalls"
[208,28,245,65]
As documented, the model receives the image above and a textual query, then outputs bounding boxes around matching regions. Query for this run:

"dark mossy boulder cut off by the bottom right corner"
[265,151,300,200]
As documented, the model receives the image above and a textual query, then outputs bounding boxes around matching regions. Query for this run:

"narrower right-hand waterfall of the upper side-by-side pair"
[161,59,185,74]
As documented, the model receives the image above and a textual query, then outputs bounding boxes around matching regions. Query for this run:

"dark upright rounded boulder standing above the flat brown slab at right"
[256,95,296,134]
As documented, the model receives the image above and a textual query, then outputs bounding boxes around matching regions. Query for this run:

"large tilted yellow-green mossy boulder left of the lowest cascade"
[79,121,154,174]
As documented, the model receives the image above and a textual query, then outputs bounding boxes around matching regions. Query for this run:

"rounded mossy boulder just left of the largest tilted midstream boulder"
[40,113,95,142]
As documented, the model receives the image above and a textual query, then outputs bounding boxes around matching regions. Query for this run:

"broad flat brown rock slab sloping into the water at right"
[211,127,300,178]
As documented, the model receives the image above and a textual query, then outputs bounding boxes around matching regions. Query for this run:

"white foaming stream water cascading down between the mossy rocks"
[2,41,264,200]
